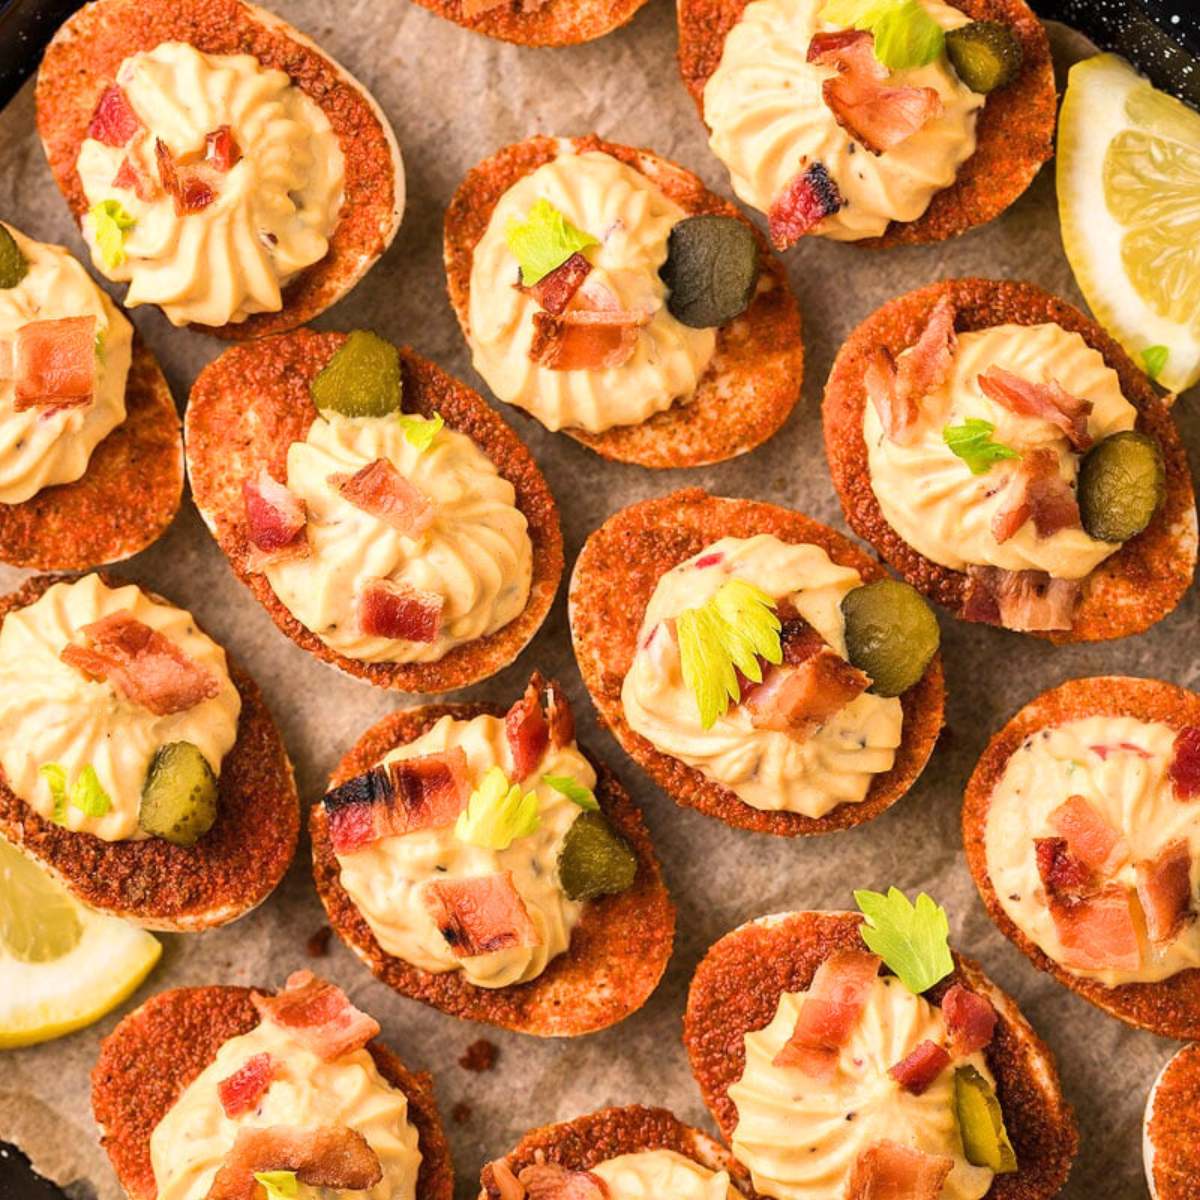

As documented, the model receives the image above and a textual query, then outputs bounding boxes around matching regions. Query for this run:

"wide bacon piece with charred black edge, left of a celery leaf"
[324,746,470,854]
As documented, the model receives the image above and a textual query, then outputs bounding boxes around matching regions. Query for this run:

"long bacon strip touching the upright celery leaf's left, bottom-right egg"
[774,950,880,1078]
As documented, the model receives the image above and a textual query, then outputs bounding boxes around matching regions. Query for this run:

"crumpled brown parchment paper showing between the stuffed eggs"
[0,9,1200,1200]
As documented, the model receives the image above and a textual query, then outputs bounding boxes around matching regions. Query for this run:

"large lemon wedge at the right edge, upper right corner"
[1056,54,1200,391]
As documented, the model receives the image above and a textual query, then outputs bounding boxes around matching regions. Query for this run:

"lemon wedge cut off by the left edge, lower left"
[0,838,162,1049]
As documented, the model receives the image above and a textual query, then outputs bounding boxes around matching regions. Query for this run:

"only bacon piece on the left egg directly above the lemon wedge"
[59,611,221,716]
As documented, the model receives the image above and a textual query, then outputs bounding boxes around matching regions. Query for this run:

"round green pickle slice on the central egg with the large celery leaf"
[841,578,941,696]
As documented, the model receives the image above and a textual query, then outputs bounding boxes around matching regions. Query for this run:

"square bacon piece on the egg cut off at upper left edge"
[12,317,96,413]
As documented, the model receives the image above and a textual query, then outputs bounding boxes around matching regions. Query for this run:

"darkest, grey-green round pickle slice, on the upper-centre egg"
[659,215,758,329]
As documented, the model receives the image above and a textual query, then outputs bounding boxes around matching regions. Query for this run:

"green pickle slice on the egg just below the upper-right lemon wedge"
[1079,430,1166,541]
